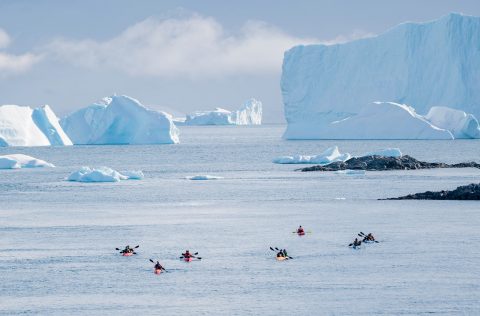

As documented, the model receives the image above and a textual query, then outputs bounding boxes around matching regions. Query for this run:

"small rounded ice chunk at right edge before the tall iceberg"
[425,106,480,138]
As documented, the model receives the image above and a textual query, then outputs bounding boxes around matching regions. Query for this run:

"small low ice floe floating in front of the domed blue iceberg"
[67,167,144,182]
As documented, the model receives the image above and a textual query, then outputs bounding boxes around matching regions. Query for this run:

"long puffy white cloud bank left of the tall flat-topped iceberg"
[47,15,318,78]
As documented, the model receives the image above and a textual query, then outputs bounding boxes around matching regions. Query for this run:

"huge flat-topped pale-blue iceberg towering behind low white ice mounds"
[281,14,480,139]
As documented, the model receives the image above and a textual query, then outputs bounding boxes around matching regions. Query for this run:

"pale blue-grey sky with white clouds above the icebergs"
[0,0,480,123]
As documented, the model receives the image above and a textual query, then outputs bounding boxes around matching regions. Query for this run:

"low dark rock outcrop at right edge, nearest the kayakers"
[387,183,480,200]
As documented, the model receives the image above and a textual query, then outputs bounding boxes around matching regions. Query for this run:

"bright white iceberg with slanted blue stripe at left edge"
[0,105,72,146]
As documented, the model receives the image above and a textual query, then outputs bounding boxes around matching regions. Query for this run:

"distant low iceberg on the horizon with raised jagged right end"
[184,98,262,125]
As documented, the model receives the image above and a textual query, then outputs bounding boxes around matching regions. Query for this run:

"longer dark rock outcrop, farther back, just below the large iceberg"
[298,155,480,171]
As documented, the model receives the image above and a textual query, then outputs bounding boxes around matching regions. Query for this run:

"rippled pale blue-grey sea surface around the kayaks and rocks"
[0,125,480,315]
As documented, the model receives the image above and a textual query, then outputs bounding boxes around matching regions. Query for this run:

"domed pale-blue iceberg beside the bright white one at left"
[60,95,179,144]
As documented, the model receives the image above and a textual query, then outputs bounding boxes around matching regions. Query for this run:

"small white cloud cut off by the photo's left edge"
[0,29,41,76]
